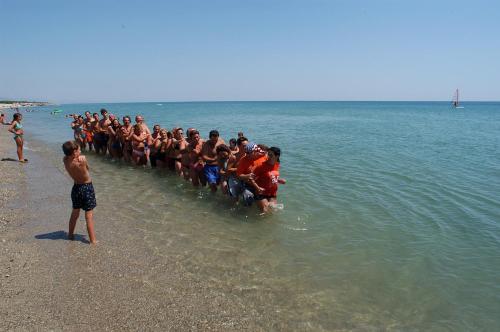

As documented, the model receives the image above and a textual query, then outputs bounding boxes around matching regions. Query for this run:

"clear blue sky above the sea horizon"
[0,0,500,102]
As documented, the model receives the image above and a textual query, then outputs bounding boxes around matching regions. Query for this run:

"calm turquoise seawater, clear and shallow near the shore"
[18,102,500,331]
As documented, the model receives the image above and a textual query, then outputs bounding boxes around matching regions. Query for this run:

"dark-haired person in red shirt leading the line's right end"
[252,146,286,213]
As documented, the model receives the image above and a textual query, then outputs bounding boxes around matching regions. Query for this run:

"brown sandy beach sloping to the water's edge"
[0,127,324,331]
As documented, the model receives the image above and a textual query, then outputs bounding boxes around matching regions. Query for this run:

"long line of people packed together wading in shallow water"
[70,109,286,213]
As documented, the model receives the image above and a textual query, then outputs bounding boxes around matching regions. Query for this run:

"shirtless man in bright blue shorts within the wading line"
[201,130,225,193]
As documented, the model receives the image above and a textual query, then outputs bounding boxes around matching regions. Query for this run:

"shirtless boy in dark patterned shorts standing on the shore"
[62,141,97,244]
